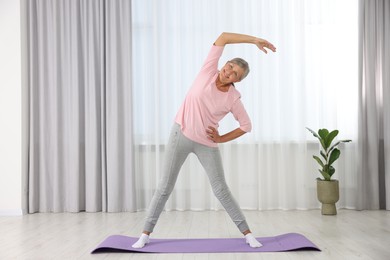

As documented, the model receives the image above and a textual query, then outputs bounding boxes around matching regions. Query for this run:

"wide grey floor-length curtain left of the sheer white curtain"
[22,0,135,213]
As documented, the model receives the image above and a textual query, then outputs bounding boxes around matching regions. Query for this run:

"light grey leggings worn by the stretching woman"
[144,123,249,232]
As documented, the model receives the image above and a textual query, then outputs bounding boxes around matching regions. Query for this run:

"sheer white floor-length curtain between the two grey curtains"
[132,0,359,210]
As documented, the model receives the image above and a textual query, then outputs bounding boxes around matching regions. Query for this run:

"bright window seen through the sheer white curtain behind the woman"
[133,0,357,144]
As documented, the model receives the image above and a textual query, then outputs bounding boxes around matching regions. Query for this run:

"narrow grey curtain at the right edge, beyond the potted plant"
[358,0,390,210]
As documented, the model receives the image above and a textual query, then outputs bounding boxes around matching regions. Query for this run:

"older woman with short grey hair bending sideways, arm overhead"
[132,33,276,248]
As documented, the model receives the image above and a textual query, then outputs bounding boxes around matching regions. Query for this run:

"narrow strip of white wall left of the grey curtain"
[0,0,22,216]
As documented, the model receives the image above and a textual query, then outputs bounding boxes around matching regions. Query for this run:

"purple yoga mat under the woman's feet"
[91,233,321,253]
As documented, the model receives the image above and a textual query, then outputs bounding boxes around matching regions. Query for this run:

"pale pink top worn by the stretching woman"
[175,45,252,147]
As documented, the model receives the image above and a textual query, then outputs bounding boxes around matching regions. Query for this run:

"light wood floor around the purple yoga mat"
[0,210,390,260]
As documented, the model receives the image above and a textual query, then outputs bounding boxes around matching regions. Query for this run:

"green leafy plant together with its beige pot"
[306,127,351,215]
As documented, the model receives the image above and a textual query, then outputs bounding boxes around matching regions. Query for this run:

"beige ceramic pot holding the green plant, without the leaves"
[317,180,339,215]
